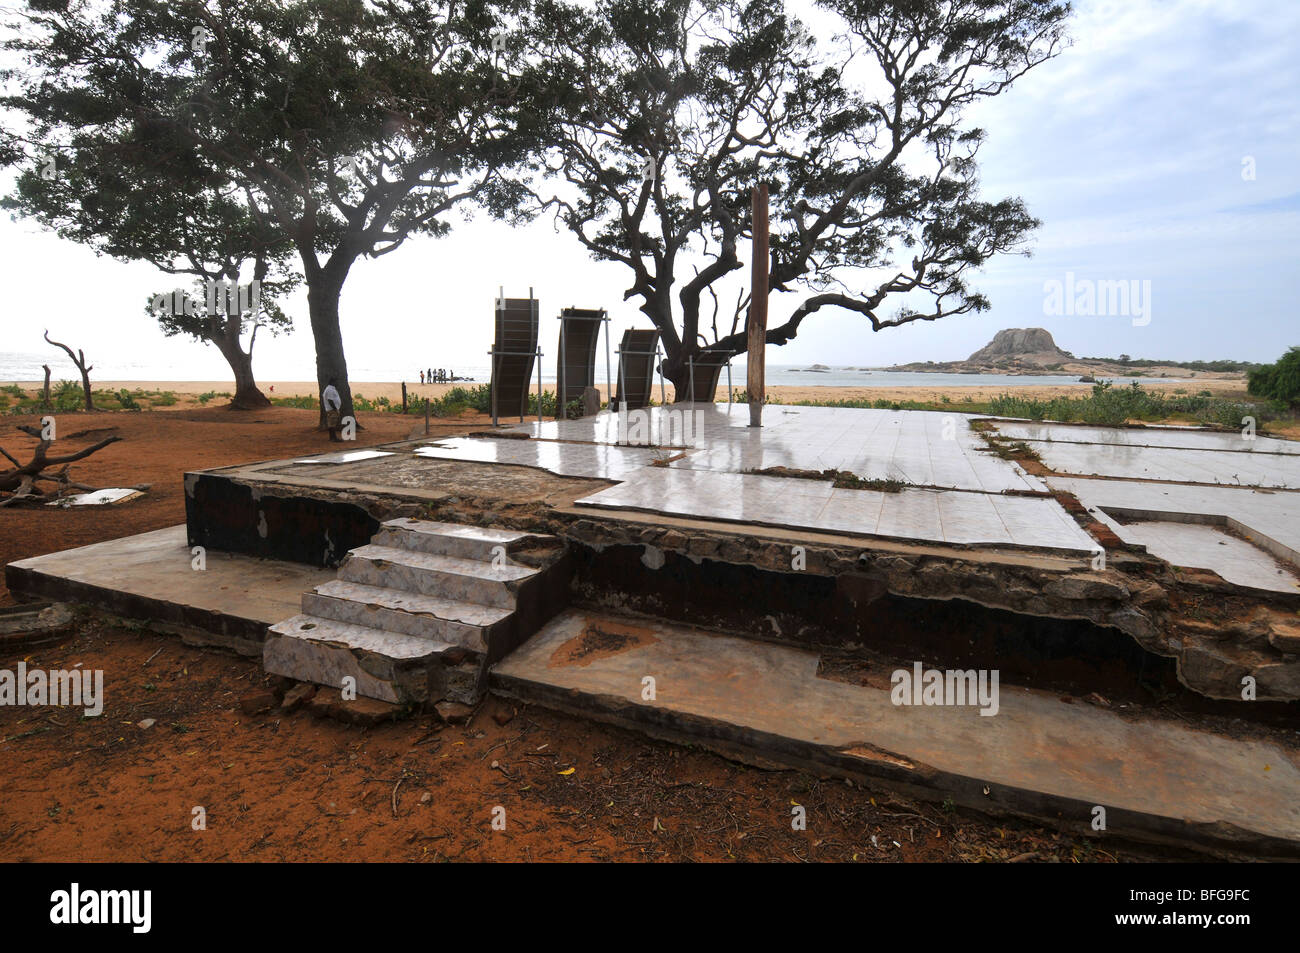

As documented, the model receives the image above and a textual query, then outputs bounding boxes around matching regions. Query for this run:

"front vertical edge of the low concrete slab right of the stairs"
[491,672,1300,861]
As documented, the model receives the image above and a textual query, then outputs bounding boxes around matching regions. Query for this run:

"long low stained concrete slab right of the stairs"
[490,610,1300,859]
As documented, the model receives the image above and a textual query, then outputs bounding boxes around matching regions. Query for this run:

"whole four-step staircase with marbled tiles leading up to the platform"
[263,519,569,705]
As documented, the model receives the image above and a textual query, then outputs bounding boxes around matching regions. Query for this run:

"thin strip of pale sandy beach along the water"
[0,376,1245,410]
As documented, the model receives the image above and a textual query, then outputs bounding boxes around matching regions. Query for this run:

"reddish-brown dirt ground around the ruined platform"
[0,397,1196,862]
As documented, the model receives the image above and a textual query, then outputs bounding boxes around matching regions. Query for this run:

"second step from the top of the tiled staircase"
[338,545,538,608]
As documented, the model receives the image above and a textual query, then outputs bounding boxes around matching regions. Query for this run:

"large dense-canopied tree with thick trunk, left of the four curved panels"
[3,0,543,417]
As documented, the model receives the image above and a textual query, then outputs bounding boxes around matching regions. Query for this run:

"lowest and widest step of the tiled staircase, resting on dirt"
[263,615,454,705]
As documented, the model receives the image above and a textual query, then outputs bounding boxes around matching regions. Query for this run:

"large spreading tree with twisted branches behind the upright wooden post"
[534,0,1069,394]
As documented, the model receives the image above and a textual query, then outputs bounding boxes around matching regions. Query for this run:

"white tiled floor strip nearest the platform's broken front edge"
[577,467,1096,554]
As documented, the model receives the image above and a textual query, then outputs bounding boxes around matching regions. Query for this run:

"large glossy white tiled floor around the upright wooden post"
[390,404,1095,553]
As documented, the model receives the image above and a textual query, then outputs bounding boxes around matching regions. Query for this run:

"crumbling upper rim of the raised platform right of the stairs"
[457,507,1300,702]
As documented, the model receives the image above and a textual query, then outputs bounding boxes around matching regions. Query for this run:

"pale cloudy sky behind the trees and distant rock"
[0,0,1300,381]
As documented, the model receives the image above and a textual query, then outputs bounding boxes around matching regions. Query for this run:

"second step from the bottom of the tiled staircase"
[303,580,511,653]
